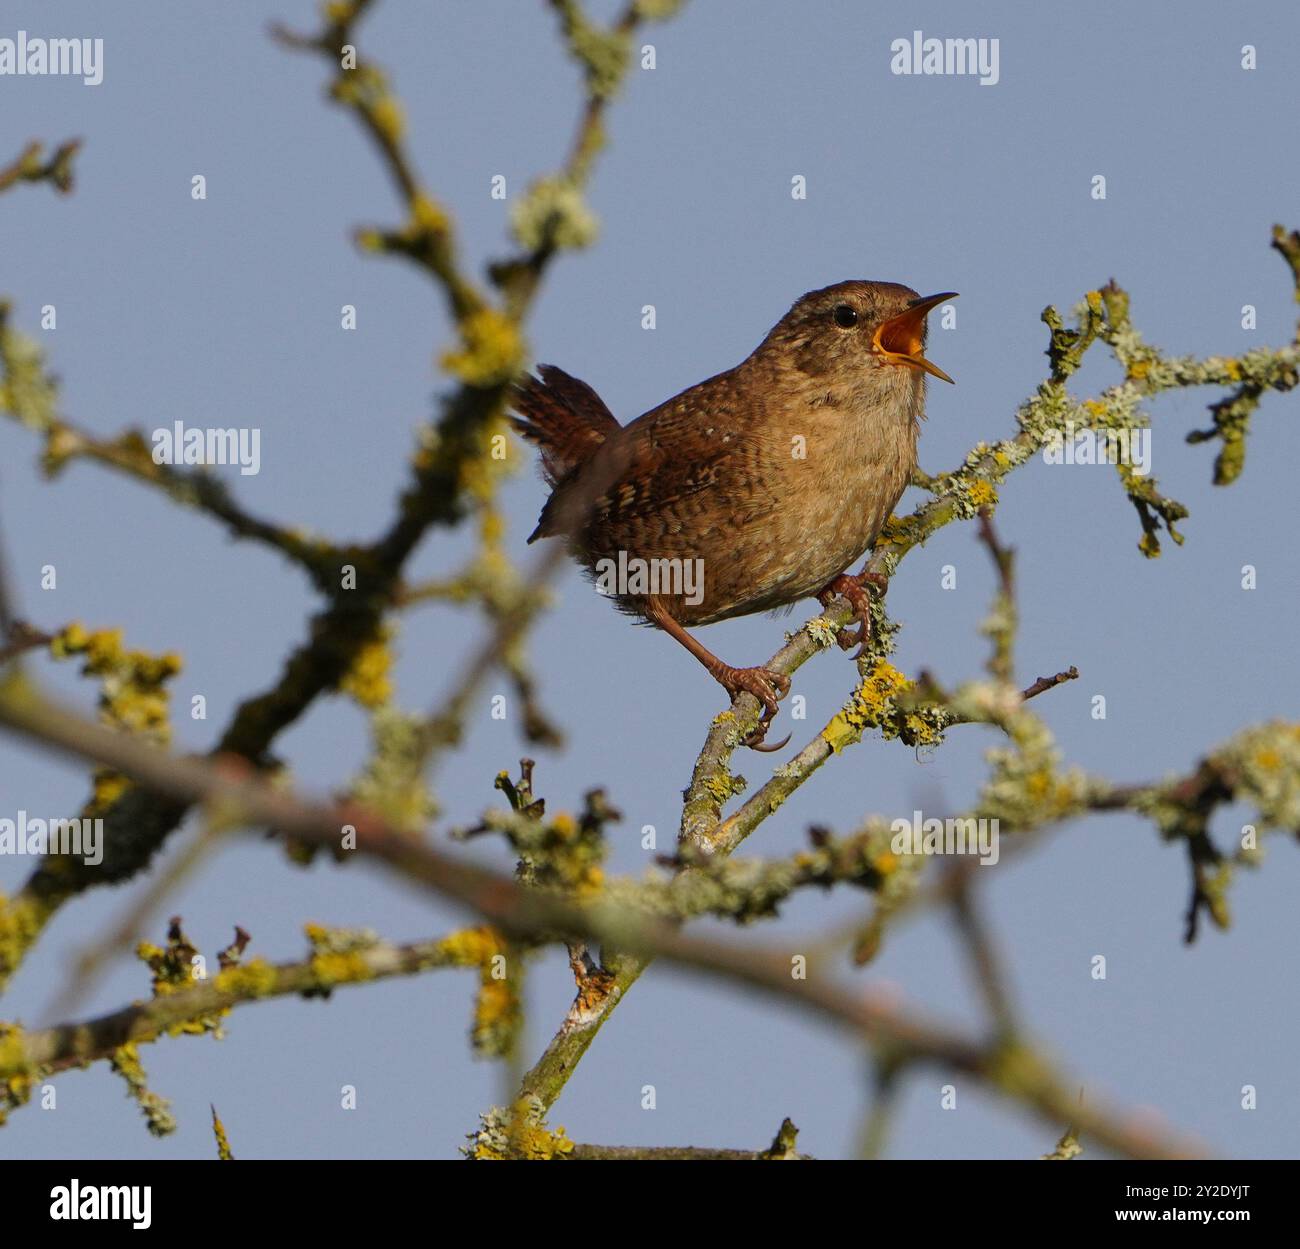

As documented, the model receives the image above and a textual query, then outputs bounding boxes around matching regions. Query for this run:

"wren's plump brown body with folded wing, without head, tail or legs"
[514,283,924,625]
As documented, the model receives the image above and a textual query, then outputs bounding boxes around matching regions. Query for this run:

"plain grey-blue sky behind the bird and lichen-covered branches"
[0,0,1300,1157]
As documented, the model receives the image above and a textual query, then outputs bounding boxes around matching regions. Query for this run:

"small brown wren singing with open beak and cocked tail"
[512,282,954,750]
